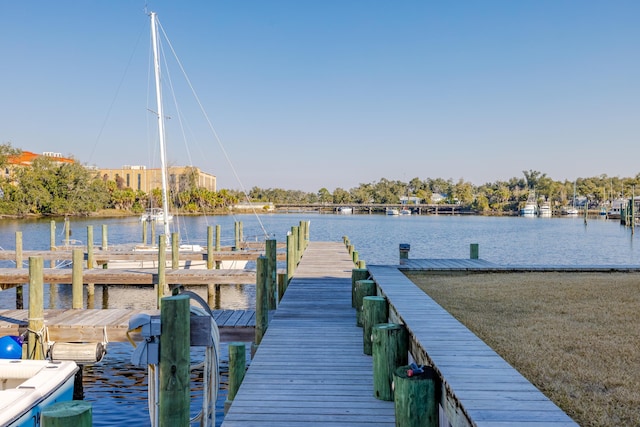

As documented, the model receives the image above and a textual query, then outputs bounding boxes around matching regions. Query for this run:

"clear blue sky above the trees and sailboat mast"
[0,0,640,191]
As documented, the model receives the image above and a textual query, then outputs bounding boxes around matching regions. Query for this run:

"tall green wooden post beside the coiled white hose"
[158,296,191,426]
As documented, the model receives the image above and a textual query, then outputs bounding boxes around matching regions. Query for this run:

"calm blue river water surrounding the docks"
[0,214,640,426]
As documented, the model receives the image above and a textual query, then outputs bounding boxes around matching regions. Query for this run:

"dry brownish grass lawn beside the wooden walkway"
[407,272,640,426]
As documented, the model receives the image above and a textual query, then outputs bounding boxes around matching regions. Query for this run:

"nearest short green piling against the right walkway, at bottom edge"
[393,366,439,427]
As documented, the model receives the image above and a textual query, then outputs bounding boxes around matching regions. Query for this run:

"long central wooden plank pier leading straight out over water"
[222,242,395,427]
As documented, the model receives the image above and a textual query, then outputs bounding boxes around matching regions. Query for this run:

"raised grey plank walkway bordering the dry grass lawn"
[368,260,577,427]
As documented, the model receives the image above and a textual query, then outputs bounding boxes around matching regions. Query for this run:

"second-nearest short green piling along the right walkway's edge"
[371,323,409,400]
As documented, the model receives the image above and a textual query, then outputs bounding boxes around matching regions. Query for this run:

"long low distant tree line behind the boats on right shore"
[239,170,640,214]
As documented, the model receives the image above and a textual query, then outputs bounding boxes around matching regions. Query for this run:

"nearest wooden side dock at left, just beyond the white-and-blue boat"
[0,309,256,342]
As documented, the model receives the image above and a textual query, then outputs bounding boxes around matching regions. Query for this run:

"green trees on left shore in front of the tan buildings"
[0,144,238,216]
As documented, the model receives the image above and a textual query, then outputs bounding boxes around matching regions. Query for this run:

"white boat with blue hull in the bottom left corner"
[0,359,78,427]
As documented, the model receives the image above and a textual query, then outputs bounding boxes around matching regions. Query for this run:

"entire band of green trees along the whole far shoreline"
[0,143,640,216]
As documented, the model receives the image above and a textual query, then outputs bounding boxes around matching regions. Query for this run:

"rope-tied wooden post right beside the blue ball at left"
[27,257,44,360]
